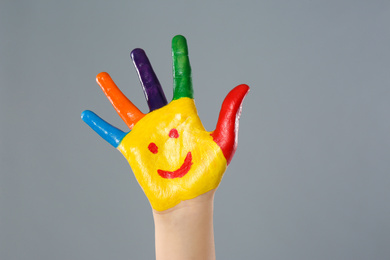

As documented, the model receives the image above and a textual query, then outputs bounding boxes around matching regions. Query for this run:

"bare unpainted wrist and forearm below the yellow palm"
[153,190,215,260]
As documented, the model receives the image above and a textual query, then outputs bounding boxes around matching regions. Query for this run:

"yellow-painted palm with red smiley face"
[118,98,227,211]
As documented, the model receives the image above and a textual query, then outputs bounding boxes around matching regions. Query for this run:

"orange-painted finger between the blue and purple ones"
[96,72,144,129]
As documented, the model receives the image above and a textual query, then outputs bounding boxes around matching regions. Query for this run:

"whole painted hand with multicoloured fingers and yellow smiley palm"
[81,35,249,211]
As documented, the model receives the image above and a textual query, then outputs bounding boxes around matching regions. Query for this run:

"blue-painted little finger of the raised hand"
[81,110,126,148]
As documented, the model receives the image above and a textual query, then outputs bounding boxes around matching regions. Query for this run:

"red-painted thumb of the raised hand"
[211,84,249,164]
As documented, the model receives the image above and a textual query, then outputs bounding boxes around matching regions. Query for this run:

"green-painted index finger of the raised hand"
[172,35,194,100]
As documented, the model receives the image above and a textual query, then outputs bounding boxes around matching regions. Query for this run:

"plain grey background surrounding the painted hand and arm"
[0,0,390,260]
